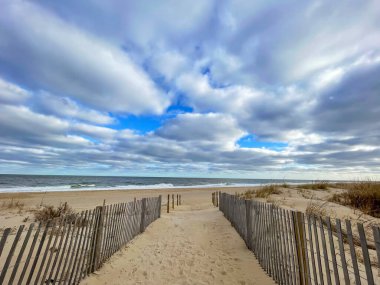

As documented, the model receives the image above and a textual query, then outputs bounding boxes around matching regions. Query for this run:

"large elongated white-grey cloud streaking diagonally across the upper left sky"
[0,1,170,114]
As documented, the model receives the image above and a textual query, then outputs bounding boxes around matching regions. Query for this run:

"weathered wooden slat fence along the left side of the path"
[0,196,161,285]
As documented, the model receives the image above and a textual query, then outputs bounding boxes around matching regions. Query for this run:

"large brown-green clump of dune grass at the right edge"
[329,181,380,218]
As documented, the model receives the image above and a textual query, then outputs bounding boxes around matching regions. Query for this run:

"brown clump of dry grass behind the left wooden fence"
[34,203,75,223]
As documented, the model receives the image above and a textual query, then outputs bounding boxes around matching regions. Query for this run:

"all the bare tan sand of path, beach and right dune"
[0,183,380,284]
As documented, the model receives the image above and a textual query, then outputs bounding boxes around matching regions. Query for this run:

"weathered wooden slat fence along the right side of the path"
[217,193,380,285]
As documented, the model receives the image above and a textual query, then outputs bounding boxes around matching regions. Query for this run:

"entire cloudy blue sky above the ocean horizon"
[0,0,380,179]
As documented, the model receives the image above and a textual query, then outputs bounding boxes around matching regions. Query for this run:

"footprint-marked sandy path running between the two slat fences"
[81,201,275,285]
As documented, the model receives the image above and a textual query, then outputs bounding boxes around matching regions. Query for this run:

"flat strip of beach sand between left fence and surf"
[0,187,252,229]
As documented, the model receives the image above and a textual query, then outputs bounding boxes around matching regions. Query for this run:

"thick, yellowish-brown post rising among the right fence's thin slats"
[293,211,309,285]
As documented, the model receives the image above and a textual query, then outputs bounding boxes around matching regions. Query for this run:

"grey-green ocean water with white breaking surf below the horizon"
[0,174,311,192]
